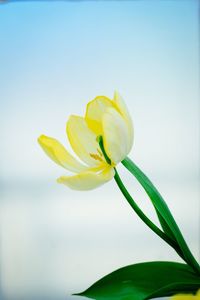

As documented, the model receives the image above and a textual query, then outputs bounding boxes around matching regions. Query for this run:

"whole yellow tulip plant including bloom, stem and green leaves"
[38,93,200,300]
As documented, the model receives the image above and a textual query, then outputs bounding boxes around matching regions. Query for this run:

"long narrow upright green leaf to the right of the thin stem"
[122,157,200,274]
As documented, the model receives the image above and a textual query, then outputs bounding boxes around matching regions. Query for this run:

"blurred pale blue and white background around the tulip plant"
[0,0,200,300]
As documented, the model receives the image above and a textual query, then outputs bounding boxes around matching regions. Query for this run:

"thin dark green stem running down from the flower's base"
[114,169,184,259]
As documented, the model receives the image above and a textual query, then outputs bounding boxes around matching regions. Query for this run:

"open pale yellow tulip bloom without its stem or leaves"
[38,92,133,190]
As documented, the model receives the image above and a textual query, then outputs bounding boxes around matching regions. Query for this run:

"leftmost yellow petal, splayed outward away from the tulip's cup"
[38,135,87,173]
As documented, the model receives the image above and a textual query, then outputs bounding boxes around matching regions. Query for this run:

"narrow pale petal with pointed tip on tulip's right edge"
[113,91,133,152]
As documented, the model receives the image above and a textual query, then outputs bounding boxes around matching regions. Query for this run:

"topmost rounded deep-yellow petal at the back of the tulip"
[85,96,113,135]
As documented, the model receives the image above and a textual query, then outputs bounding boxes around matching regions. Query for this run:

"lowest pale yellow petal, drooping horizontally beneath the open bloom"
[57,167,115,191]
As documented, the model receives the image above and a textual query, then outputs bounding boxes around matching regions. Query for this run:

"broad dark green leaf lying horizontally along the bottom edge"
[76,262,200,300]
